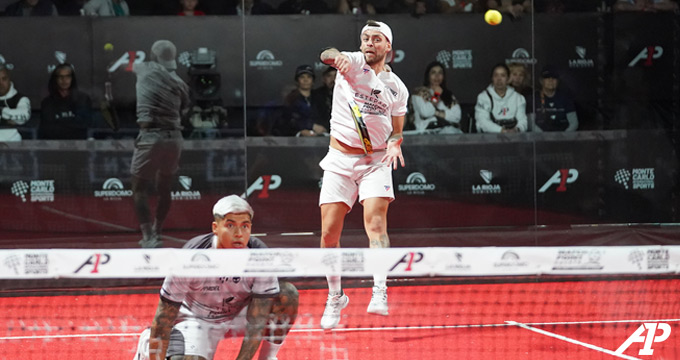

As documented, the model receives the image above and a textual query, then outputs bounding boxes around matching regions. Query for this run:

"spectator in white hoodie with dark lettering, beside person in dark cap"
[475,64,527,133]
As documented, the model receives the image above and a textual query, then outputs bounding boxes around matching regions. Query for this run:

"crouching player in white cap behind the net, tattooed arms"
[134,195,298,360]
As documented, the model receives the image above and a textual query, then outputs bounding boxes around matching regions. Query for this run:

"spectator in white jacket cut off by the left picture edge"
[0,65,31,142]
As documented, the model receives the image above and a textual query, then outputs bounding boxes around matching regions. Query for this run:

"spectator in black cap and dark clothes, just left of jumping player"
[272,65,320,136]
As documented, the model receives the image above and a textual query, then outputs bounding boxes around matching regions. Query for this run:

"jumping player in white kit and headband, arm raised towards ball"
[319,20,408,329]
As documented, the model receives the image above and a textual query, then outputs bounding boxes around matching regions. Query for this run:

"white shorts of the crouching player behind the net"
[133,306,248,360]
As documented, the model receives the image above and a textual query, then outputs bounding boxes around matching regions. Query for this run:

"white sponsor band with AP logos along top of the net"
[0,246,680,279]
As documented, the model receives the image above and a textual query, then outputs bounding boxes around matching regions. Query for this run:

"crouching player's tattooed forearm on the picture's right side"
[236,297,274,360]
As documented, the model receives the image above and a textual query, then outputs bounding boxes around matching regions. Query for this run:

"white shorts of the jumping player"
[319,148,394,210]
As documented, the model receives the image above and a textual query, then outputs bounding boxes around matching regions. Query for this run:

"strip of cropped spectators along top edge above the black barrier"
[0,0,678,18]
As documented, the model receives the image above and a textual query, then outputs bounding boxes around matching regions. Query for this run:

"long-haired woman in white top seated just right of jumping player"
[411,61,462,134]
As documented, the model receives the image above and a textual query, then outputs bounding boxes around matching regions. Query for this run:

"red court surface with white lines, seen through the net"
[0,279,680,360]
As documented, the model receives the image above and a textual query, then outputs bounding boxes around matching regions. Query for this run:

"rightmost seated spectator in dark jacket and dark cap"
[529,66,578,132]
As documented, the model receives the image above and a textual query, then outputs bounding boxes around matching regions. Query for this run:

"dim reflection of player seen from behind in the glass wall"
[130,40,189,248]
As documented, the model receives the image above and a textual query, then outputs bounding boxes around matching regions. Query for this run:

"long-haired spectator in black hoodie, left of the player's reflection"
[38,63,92,140]
